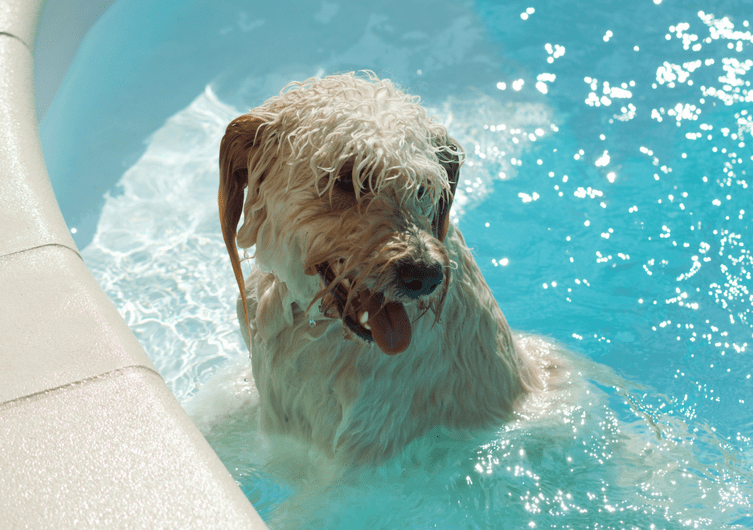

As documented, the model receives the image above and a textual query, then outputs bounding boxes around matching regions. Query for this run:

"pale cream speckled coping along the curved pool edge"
[0,0,266,529]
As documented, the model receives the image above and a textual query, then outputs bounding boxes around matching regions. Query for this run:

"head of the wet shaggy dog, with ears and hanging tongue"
[219,74,462,354]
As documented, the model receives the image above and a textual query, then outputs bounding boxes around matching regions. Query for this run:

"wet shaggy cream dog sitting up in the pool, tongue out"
[218,72,556,462]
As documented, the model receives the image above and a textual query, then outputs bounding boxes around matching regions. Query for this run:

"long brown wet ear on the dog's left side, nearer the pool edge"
[217,114,262,336]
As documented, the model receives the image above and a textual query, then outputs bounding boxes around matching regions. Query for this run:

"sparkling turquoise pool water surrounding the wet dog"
[41,0,753,529]
